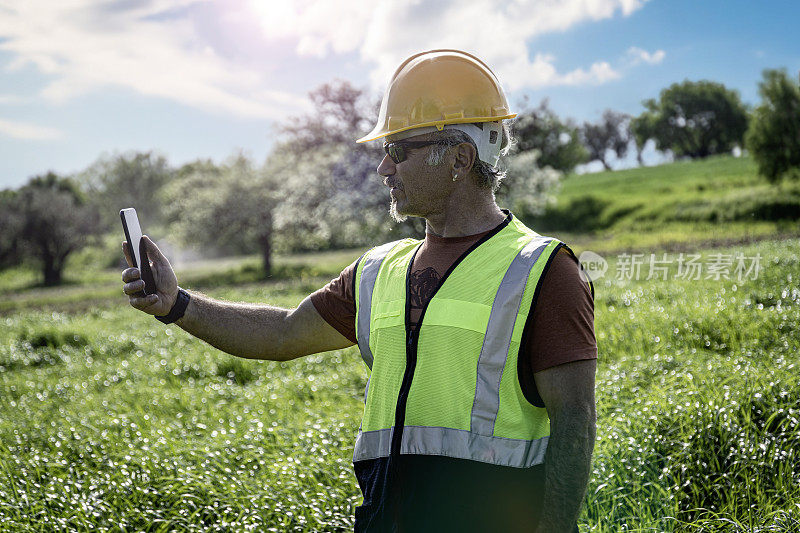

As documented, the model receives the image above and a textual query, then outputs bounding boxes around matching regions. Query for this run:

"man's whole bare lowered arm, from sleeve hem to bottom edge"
[534,359,597,533]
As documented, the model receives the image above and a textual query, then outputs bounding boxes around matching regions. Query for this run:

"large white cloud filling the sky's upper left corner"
[0,0,307,119]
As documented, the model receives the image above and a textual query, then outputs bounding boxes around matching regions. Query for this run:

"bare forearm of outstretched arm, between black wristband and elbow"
[175,292,292,360]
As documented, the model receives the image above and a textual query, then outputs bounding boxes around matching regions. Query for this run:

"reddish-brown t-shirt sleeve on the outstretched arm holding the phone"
[311,261,358,344]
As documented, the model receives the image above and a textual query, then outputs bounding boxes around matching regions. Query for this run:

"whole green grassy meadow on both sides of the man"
[0,156,800,532]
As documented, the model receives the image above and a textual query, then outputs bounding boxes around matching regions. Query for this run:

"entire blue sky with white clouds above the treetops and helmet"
[0,0,800,188]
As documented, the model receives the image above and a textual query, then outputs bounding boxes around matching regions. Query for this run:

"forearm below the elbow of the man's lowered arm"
[538,409,596,533]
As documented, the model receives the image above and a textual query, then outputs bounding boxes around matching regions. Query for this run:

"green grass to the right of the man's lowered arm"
[587,241,800,531]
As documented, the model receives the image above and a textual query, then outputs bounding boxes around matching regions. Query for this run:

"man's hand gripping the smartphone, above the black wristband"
[122,235,178,316]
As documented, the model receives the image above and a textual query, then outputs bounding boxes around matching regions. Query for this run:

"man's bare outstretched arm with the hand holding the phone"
[122,237,353,361]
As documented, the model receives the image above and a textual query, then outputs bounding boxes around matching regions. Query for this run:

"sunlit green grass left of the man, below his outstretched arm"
[0,302,363,531]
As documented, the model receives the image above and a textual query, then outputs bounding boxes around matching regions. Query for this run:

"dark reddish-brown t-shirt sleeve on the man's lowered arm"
[522,243,597,373]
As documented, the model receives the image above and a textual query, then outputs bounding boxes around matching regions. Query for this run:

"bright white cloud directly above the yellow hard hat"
[251,0,647,90]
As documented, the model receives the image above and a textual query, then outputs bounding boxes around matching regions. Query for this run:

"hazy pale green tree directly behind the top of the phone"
[79,152,173,228]
